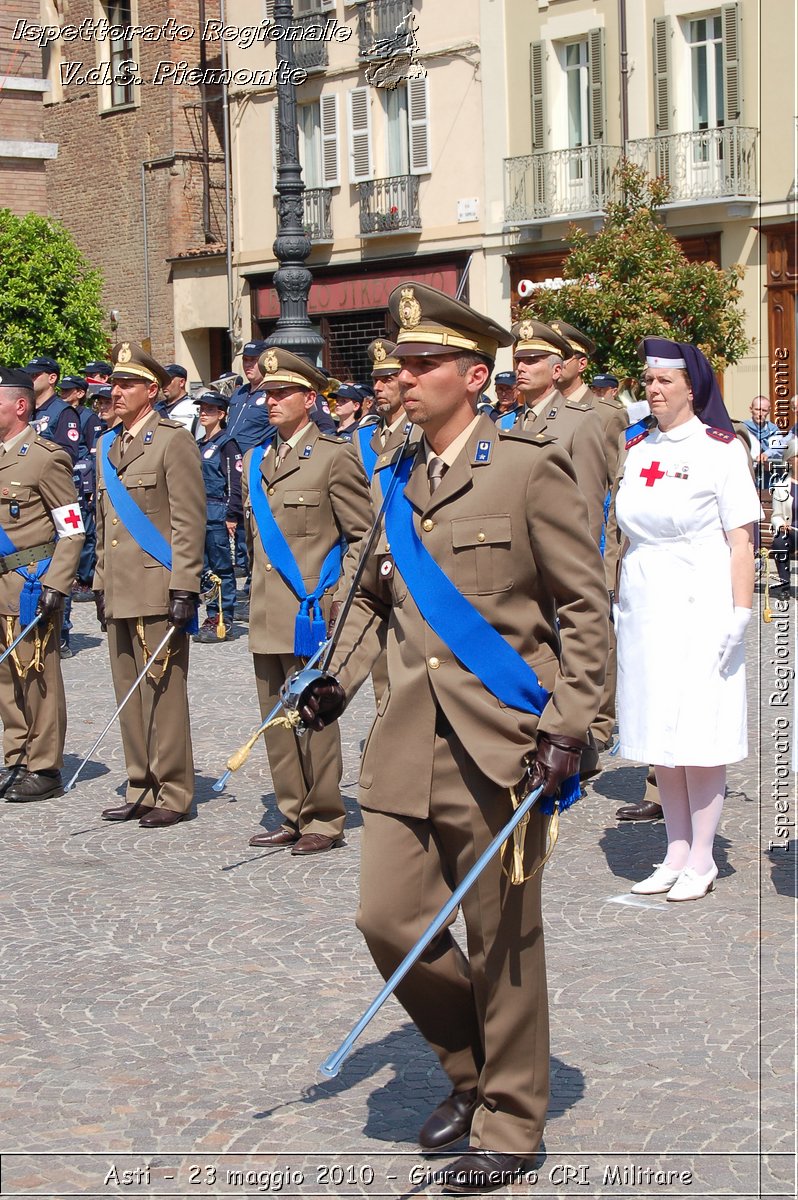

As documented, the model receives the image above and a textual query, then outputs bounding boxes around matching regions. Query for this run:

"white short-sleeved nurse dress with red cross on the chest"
[616,416,761,767]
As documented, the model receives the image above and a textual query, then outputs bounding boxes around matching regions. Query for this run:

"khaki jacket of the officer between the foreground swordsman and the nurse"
[522,389,608,546]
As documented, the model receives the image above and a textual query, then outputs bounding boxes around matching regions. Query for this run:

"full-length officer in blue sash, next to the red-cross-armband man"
[94,342,205,829]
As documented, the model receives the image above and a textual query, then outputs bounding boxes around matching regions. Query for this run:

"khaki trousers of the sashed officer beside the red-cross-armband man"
[108,616,194,812]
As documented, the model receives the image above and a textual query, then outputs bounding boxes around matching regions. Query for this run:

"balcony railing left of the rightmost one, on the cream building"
[504,145,620,224]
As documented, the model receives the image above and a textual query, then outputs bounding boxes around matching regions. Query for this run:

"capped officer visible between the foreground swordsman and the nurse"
[496,320,607,546]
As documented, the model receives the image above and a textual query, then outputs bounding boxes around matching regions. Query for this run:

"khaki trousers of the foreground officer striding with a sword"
[358,734,548,1154]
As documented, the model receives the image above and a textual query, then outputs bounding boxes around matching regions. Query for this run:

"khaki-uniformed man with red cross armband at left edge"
[0,367,83,800]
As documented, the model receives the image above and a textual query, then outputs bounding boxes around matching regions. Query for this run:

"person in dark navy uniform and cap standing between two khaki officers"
[194,391,244,642]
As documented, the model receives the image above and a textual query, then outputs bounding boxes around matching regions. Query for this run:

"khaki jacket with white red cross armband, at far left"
[0,428,84,616]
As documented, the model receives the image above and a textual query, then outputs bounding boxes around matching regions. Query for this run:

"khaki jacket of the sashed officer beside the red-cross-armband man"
[94,412,206,619]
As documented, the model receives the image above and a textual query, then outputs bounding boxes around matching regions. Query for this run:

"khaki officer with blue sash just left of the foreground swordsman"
[242,348,371,854]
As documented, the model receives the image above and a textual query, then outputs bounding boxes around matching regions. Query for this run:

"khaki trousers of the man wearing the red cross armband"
[0,617,66,770]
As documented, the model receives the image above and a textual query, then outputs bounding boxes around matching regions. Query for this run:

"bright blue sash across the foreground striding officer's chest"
[385,456,580,812]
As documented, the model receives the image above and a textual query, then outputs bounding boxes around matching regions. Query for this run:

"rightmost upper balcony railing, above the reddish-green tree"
[628,125,757,204]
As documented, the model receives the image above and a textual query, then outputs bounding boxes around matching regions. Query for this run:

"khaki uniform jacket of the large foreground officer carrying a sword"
[331,413,607,817]
